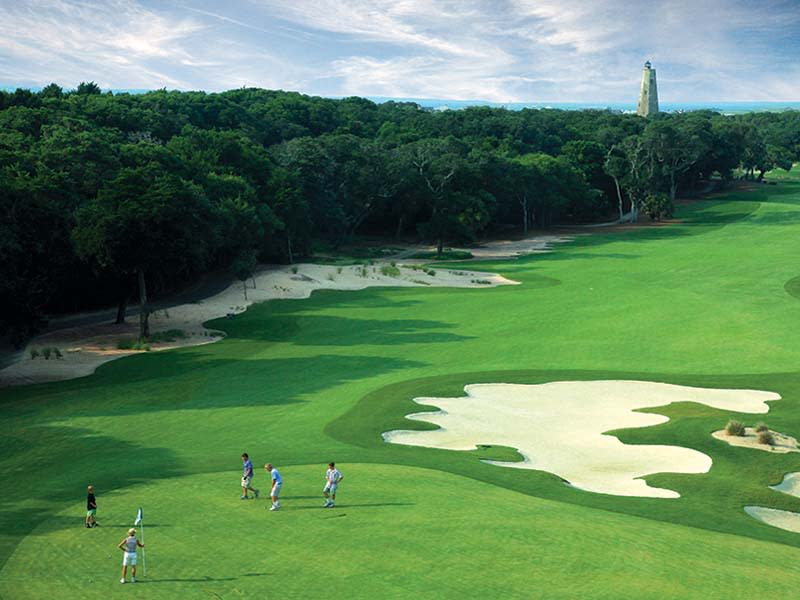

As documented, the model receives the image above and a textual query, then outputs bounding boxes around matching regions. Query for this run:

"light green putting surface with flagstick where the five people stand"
[0,464,800,599]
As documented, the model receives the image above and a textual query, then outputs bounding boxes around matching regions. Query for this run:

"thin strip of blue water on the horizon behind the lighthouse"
[369,96,800,114]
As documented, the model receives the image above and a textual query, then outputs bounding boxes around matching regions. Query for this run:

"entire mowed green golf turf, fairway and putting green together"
[0,173,800,598]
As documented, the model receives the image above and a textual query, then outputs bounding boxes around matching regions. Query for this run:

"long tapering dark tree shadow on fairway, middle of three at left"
[0,354,425,414]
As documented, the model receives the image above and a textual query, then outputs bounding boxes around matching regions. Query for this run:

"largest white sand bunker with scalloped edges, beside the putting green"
[383,381,780,498]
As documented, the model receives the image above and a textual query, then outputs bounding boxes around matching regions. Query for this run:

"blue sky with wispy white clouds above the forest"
[0,0,800,102]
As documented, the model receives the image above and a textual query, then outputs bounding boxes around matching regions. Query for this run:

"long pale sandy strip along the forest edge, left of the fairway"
[0,263,518,387]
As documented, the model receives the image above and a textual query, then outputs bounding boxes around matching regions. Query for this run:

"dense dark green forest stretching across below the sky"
[0,83,800,343]
